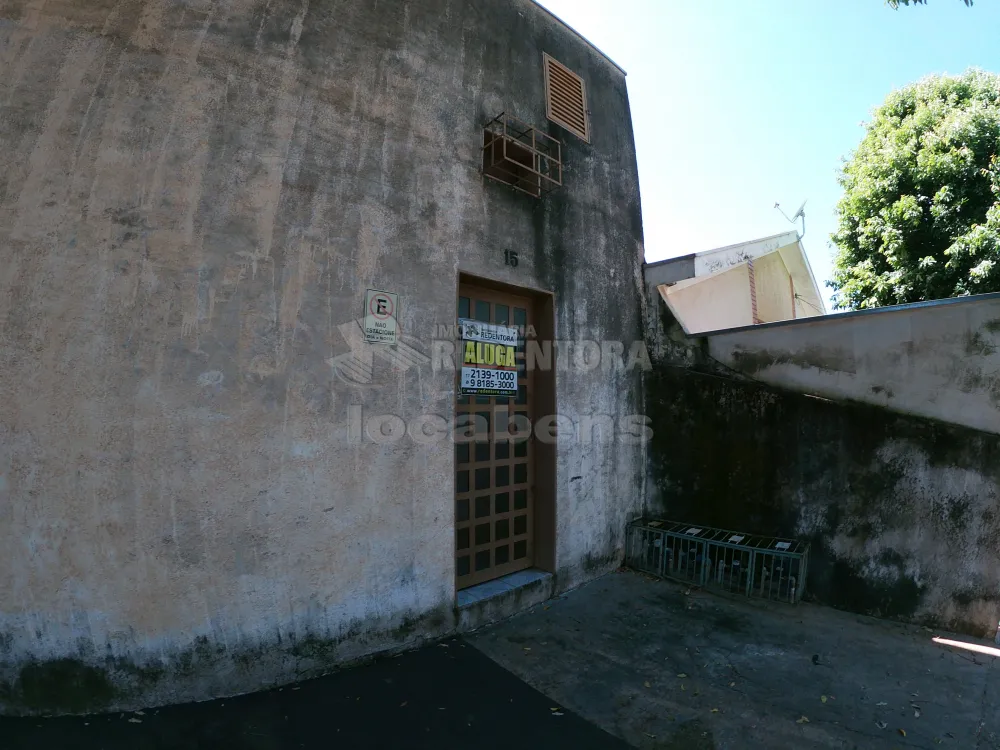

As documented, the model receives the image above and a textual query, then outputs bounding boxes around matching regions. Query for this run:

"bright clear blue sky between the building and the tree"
[540,0,1000,310]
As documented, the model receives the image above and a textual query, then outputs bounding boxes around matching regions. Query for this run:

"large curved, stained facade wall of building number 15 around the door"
[0,0,644,712]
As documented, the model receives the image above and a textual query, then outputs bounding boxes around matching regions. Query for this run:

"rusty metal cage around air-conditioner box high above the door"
[483,112,562,198]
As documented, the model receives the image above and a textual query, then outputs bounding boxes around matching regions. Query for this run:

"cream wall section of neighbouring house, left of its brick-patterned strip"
[667,263,753,333]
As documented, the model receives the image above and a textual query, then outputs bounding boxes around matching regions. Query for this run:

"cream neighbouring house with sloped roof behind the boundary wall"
[645,232,826,333]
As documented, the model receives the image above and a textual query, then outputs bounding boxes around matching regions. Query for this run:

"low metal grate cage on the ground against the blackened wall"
[625,518,809,603]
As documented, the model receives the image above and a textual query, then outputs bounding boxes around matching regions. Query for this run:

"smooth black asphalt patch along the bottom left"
[0,640,628,750]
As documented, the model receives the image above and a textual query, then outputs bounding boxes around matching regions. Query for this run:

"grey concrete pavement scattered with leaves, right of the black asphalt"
[470,573,1000,750]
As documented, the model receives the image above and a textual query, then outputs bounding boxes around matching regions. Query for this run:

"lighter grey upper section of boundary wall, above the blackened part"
[707,294,1000,433]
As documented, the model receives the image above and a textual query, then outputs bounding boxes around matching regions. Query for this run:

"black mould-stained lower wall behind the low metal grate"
[647,364,1000,636]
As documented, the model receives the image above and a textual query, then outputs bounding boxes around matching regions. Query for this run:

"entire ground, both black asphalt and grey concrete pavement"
[0,573,1000,750]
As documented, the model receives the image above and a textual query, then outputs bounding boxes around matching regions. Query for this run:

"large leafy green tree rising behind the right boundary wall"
[827,70,1000,309]
